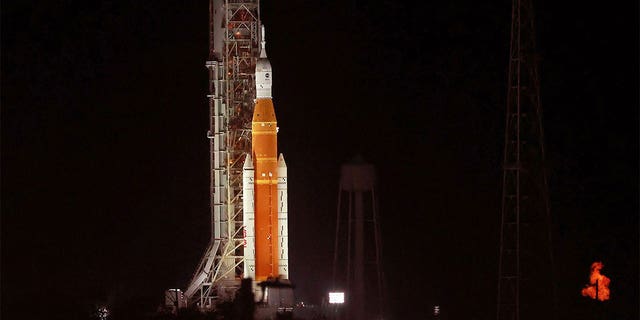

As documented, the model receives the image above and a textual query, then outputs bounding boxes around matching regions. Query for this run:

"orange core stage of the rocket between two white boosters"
[251,98,278,281]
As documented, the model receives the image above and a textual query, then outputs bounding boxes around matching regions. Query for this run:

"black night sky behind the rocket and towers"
[0,0,640,319]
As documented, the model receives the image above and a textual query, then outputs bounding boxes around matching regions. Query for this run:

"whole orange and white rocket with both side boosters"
[243,27,289,282]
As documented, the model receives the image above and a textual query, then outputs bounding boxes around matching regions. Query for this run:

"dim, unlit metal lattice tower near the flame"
[497,0,556,320]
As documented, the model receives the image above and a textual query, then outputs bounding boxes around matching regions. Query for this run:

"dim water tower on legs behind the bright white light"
[332,156,384,320]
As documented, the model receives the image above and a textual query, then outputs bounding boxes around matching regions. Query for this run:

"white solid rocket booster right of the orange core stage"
[278,153,289,279]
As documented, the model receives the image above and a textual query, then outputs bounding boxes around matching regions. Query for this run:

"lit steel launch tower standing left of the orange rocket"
[185,0,260,310]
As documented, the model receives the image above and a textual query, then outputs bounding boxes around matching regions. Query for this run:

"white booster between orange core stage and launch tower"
[242,154,256,279]
